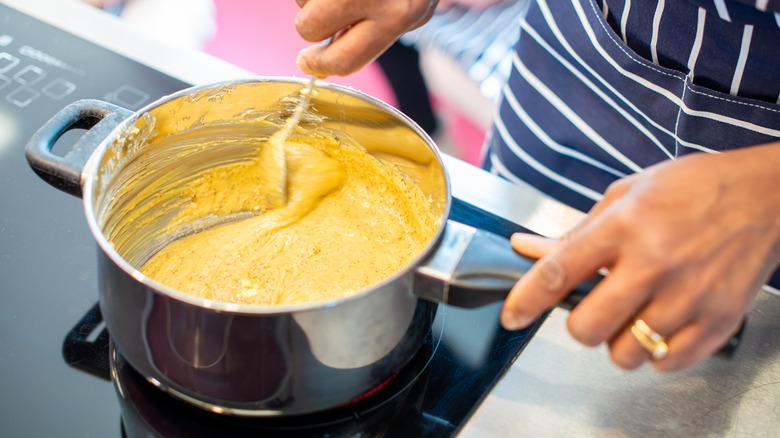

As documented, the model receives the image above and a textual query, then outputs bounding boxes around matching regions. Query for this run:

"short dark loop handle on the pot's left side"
[26,99,133,197]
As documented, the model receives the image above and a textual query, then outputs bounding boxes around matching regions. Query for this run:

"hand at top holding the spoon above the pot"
[295,0,436,77]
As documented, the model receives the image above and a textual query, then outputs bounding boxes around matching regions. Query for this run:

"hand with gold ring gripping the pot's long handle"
[501,143,780,371]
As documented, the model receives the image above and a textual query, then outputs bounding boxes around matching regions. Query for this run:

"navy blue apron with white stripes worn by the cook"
[483,0,780,285]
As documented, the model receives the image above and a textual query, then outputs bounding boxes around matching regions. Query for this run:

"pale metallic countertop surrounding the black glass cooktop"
[7,0,780,437]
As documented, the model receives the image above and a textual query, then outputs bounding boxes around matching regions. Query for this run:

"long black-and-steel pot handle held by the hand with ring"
[414,221,745,358]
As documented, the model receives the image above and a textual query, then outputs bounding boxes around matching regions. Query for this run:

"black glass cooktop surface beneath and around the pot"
[0,5,537,437]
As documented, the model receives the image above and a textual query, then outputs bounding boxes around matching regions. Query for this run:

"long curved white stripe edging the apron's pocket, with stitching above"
[564,0,780,138]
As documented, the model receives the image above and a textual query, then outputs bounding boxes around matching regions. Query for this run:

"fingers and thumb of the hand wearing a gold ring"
[501,214,744,371]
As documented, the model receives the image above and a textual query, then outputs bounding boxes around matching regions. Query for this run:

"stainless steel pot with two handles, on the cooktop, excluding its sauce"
[27,78,591,416]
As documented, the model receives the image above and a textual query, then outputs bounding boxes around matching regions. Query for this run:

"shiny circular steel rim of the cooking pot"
[81,76,452,315]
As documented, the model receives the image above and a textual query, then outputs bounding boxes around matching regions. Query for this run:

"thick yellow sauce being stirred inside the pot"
[141,133,439,305]
